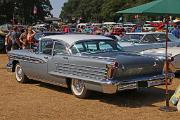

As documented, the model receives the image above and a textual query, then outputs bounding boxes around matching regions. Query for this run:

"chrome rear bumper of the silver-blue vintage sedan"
[85,73,175,94]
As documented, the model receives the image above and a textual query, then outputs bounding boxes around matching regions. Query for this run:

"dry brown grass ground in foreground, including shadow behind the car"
[0,55,180,120]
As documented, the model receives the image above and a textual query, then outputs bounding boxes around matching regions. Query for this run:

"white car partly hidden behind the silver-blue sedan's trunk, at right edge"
[140,47,180,73]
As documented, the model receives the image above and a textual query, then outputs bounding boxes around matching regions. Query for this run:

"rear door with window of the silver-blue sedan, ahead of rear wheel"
[47,41,70,84]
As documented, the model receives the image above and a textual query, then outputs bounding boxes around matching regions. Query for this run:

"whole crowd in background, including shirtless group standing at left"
[2,21,180,52]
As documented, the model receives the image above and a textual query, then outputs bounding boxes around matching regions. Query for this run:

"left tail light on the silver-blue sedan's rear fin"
[106,62,119,79]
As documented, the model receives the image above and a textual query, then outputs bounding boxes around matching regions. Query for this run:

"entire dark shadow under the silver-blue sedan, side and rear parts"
[26,81,174,108]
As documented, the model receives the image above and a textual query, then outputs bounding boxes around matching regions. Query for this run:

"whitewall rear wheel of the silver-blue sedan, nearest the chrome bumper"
[71,79,89,99]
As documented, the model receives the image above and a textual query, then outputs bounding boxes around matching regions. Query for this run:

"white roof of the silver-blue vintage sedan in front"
[44,34,113,45]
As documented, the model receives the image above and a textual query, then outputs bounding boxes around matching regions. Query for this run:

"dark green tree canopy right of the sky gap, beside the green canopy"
[60,0,152,22]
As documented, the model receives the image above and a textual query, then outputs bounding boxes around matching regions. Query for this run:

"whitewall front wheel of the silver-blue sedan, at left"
[15,63,28,83]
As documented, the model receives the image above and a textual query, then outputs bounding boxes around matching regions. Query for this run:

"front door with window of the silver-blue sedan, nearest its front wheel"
[23,39,54,81]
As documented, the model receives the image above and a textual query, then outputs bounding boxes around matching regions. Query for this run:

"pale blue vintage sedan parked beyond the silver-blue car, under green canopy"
[118,32,180,52]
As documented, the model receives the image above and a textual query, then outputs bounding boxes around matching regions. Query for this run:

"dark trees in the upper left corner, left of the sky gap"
[0,0,52,24]
